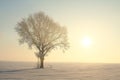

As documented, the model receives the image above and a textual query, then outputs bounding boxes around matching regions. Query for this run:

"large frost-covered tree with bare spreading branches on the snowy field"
[15,12,69,68]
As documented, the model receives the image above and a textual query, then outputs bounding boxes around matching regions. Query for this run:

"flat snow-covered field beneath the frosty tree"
[0,62,120,80]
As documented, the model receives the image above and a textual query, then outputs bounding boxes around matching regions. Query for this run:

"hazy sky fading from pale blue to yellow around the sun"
[0,0,120,63]
